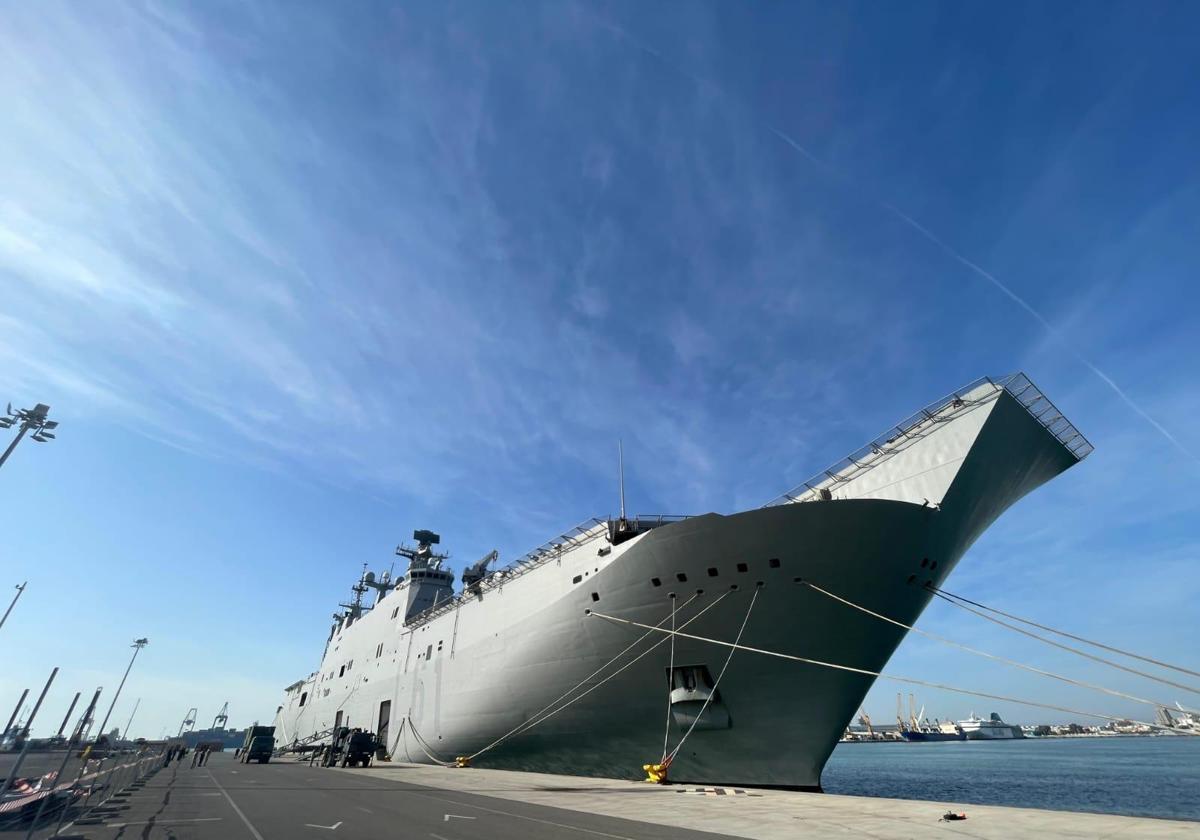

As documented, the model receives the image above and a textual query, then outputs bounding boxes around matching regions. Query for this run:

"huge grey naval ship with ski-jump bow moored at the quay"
[275,373,1092,790]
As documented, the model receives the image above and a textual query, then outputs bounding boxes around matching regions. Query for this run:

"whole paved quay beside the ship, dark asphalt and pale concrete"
[7,754,1200,840]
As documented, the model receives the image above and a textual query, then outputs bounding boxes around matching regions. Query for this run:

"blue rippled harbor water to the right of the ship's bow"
[822,736,1200,821]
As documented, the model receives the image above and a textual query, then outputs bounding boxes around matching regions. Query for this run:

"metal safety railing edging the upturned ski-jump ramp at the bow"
[763,373,1093,508]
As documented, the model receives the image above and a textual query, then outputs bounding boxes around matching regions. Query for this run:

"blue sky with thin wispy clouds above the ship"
[0,2,1200,736]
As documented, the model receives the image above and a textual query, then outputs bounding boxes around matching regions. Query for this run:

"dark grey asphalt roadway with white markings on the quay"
[16,754,725,840]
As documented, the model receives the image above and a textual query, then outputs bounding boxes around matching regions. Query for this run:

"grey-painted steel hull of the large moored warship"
[276,384,1076,788]
